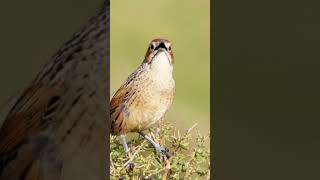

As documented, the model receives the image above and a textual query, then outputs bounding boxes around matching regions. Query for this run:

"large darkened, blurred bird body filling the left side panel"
[0,0,110,180]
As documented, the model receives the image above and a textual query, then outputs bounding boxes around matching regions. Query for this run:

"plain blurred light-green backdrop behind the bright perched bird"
[110,0,210,133]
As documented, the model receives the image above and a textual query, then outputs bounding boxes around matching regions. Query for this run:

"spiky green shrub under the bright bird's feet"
[110,124,210,179]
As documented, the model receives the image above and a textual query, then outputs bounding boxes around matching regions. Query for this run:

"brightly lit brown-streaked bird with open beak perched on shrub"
[110,39,175,157]
